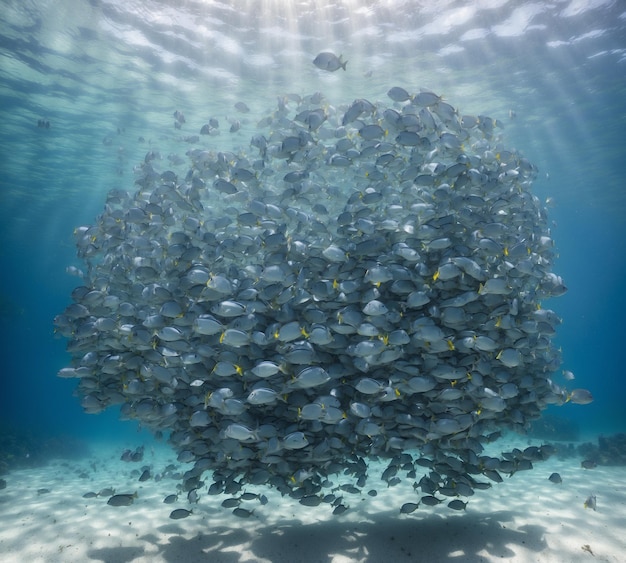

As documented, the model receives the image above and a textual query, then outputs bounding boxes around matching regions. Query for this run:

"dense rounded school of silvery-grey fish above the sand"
[55,87,591,517]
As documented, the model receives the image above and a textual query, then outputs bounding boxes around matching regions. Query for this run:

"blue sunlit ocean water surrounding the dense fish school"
[0,0,626,468]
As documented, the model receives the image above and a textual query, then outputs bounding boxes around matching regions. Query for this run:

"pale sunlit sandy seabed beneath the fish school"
[0,437,626,563]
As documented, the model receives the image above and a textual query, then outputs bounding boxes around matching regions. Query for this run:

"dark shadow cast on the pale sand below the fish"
[89,511,546,563]
